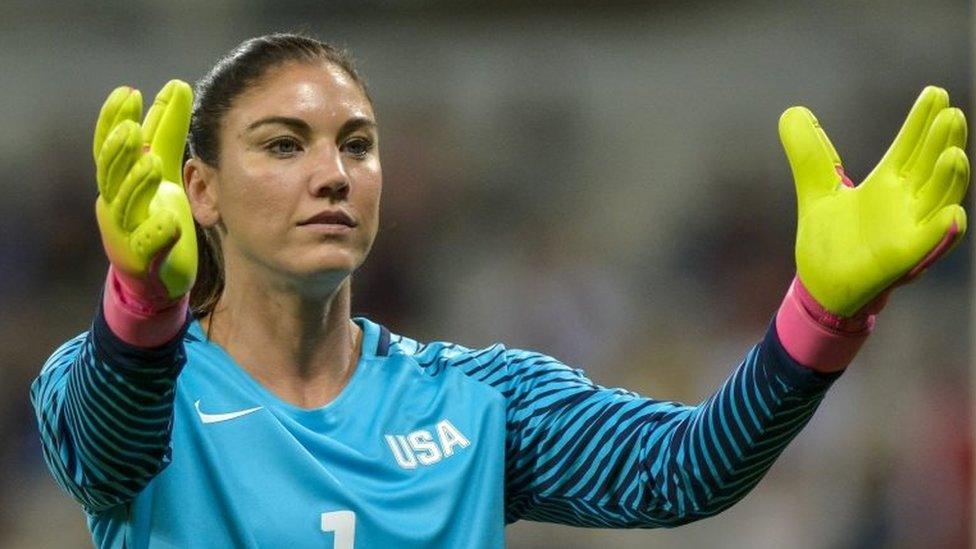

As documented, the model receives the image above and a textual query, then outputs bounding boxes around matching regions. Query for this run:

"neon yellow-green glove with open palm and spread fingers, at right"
[779,86,969,318]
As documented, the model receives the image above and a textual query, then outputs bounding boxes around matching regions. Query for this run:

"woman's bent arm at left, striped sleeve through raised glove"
[31,80,197,513]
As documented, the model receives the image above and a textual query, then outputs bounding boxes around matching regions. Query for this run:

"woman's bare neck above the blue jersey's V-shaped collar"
[200,273,362,408]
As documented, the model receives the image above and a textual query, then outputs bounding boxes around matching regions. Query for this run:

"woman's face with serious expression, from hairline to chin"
[208,62,383,284]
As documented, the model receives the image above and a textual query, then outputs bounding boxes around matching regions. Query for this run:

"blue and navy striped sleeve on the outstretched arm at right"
[432,316,841,528]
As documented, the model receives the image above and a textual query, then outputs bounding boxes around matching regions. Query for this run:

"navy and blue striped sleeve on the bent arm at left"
[30,298,189,513]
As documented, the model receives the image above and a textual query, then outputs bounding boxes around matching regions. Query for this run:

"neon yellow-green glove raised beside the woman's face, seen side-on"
[93,80,197,304]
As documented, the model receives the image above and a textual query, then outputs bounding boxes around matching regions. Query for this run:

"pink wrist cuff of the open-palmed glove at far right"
[776,277,874,372]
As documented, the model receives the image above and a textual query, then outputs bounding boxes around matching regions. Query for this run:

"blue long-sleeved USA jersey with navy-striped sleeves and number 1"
[31,302,840,549]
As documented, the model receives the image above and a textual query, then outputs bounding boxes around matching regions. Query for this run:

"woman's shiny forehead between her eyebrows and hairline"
[228,61,373,126]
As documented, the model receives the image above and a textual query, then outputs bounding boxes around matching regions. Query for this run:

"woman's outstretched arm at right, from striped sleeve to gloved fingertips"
[504,86,969,527]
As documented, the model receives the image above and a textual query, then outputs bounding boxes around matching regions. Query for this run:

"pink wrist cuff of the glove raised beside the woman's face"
[102,265,190,348]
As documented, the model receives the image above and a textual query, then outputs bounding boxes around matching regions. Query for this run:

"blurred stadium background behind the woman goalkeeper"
[0,0,976,549]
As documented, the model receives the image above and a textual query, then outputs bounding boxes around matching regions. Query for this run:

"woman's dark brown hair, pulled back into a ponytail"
[186,33,372,318]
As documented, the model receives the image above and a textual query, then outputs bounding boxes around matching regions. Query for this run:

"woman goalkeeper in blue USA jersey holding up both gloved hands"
[31,35,968,548]
